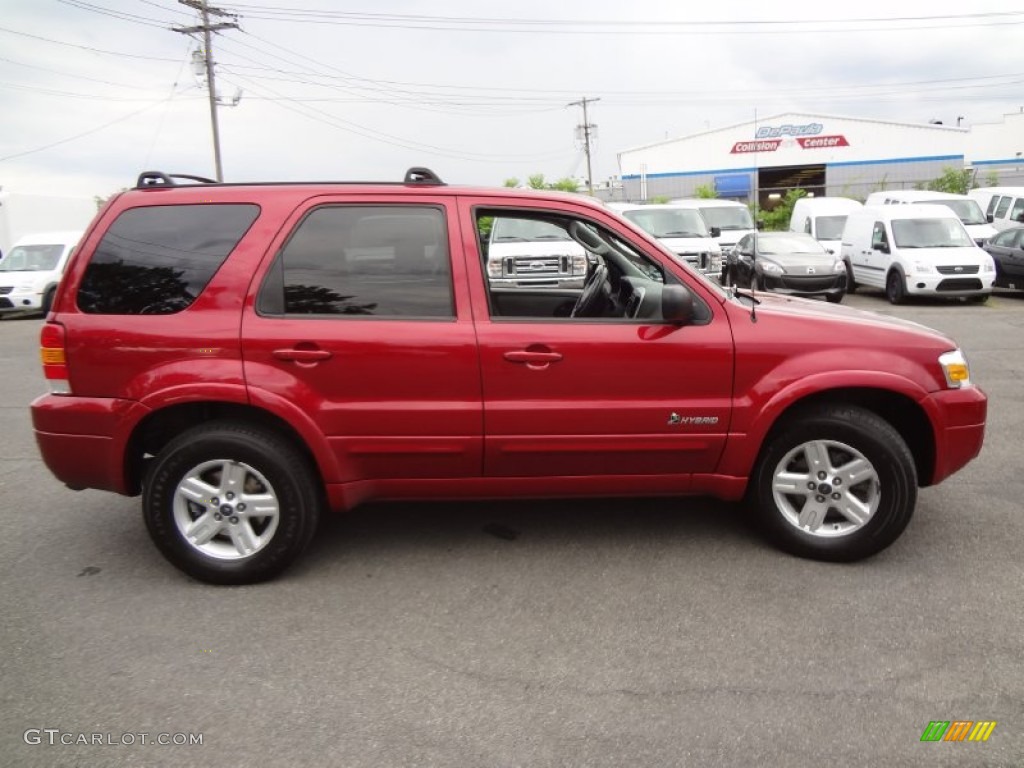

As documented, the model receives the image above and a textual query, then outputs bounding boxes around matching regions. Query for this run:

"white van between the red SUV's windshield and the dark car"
[608,203,722,278]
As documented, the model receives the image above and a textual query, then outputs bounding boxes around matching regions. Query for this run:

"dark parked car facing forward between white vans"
[725,232,846,303]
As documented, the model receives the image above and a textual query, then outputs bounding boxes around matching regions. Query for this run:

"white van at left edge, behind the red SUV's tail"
[0,231,82,313]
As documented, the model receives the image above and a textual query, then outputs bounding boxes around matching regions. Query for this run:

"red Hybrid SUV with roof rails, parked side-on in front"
[32,169,986,584]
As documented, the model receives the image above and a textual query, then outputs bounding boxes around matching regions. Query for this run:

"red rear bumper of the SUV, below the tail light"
[32,394,148,495]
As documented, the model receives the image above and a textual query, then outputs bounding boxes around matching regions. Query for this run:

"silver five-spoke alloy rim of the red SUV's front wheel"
[772,440,882,538]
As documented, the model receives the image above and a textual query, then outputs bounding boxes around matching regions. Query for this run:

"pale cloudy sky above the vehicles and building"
[0,0,1024,197]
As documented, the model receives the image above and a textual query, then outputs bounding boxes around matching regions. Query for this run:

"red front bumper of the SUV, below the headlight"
[923,387,988,485]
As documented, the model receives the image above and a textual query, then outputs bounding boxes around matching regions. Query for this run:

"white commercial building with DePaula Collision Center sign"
[618,111,1024,207]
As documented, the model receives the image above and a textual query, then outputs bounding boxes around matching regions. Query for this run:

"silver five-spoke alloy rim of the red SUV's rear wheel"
[173,459,281,560]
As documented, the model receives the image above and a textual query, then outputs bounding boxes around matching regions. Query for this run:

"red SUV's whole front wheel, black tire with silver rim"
[748,406,918,562]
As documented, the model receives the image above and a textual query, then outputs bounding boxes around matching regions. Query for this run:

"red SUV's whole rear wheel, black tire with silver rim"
[142,422,322,584]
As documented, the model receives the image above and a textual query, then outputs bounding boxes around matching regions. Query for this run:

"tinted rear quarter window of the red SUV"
[78,204,259,314]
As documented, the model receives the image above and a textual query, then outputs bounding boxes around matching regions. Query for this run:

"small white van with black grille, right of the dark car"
[843,204,995,304]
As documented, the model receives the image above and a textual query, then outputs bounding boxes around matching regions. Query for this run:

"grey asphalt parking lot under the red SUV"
[0,291,1024,768]
